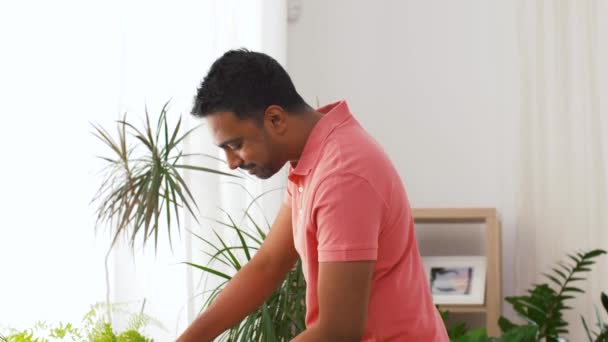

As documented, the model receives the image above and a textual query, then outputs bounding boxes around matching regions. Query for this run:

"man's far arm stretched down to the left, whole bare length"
[178,205,298,342]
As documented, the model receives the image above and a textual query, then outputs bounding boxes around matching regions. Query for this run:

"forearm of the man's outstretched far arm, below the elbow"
[177,260,284,342]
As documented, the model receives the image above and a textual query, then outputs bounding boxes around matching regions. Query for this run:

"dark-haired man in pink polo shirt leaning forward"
[179,50,448,342]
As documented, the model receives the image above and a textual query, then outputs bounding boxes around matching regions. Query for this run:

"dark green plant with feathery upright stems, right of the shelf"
[499,249,606,342]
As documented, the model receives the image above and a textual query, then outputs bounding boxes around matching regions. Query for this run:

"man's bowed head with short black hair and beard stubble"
[192,50,310,179]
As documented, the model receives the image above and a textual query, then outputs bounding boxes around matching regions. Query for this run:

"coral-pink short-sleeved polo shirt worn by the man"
[285,101,448,342]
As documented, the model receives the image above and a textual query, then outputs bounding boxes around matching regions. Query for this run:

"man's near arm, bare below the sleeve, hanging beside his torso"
[293,261,375,342]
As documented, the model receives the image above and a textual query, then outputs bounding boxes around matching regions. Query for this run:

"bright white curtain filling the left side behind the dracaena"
[0,0,287,341]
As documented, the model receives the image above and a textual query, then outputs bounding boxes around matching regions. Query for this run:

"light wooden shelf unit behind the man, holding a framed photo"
[413,208,502,336]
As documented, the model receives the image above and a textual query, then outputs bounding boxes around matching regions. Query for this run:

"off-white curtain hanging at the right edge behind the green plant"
[515,0,608,341]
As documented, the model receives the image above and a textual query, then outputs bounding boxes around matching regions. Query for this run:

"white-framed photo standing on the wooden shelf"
[422,256,486,305]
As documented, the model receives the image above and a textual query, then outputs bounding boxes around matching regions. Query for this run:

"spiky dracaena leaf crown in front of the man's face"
[92,102,237,248]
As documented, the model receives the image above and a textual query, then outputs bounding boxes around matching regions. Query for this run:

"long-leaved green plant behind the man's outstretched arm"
[187,206,306,341]
